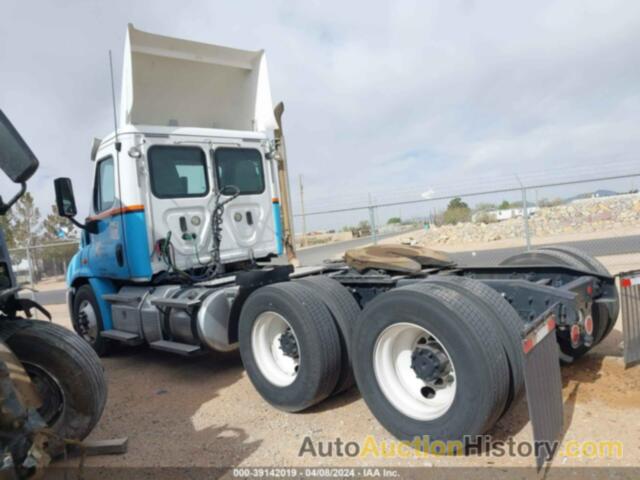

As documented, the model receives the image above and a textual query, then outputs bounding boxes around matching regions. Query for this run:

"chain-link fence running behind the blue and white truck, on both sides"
[9,174,640,285]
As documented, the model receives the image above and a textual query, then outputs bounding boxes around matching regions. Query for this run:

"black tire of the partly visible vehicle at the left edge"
[7,320,107,456]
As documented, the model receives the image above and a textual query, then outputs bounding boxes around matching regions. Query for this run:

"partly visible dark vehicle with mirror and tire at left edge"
[0,110,107,479]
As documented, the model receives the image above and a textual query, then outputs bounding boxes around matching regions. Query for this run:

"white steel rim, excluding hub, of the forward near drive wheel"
[251,312,300,387]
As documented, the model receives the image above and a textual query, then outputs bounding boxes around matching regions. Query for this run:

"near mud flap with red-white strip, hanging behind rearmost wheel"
[522,305,563,470]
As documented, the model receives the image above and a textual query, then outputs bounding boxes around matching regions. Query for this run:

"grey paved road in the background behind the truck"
[36,234,640,305]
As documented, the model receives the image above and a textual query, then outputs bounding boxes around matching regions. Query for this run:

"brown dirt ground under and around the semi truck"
[42,257,640,476]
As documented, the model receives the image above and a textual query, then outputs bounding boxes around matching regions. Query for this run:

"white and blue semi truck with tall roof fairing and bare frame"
[55,25,636,466]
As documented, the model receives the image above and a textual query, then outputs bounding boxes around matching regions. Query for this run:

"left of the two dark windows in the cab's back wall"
[148,145,209,198]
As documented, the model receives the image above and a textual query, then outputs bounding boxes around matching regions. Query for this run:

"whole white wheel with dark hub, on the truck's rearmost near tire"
[373,323,456,421]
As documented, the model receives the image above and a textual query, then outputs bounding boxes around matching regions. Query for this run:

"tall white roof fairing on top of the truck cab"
[120,24,276,131]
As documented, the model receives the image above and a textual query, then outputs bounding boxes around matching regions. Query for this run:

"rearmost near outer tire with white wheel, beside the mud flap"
[352,283,509,449]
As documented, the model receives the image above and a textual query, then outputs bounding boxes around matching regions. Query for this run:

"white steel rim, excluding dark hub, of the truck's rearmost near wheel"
[373,323,457,421]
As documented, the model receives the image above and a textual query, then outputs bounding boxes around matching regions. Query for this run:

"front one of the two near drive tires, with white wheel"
[238,282,342,412]
